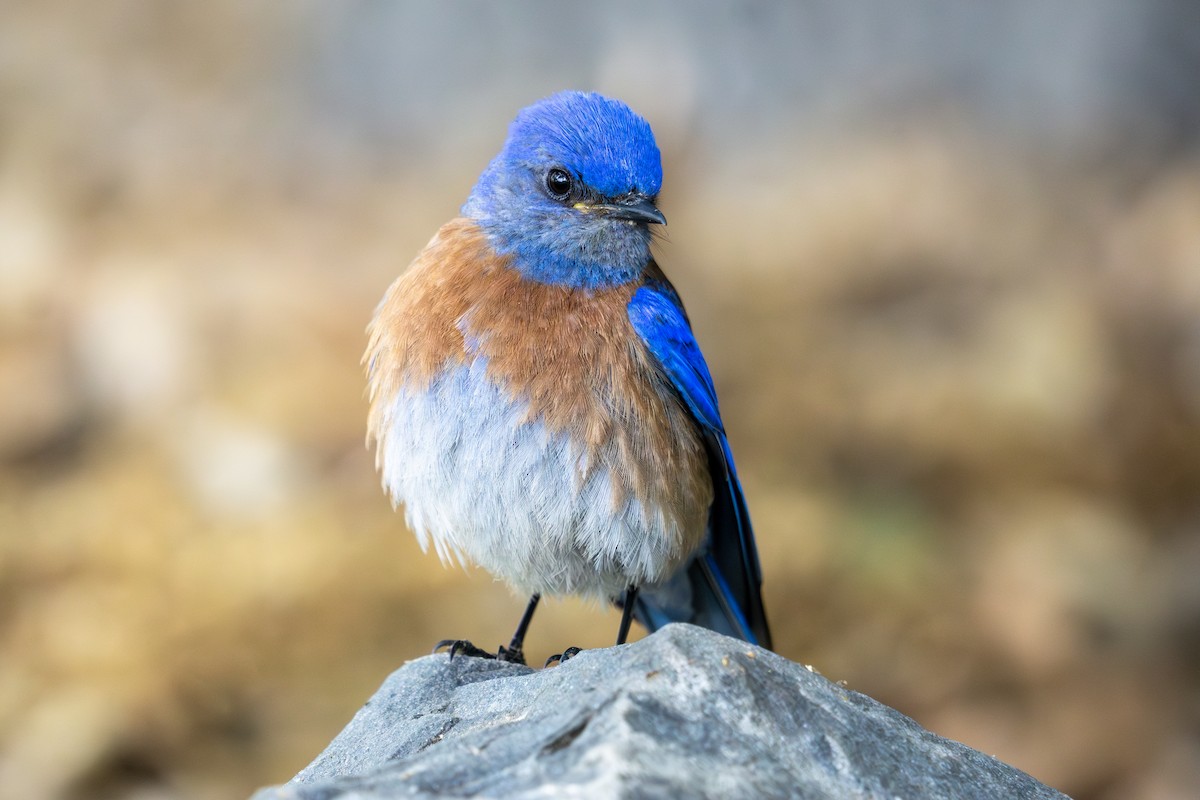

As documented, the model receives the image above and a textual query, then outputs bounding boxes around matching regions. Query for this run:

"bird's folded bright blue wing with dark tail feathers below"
[628,269,770,648]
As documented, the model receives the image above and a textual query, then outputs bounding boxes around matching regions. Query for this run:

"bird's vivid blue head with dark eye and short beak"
[462,91,665,288]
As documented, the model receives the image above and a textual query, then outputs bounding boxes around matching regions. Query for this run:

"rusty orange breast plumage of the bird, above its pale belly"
[365,218,712,517]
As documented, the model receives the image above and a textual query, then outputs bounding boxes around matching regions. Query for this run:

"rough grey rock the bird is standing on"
[254,625,1066,800]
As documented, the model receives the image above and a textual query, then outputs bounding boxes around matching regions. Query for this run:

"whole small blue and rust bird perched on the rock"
[362,91,772,664]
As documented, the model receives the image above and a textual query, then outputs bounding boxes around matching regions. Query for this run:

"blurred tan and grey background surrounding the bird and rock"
[0,0,1200,800]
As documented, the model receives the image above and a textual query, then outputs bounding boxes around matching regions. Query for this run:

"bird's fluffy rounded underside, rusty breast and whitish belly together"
[366,219,712,596]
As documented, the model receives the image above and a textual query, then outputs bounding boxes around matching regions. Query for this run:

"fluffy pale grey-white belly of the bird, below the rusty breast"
[377,361,703,599]
